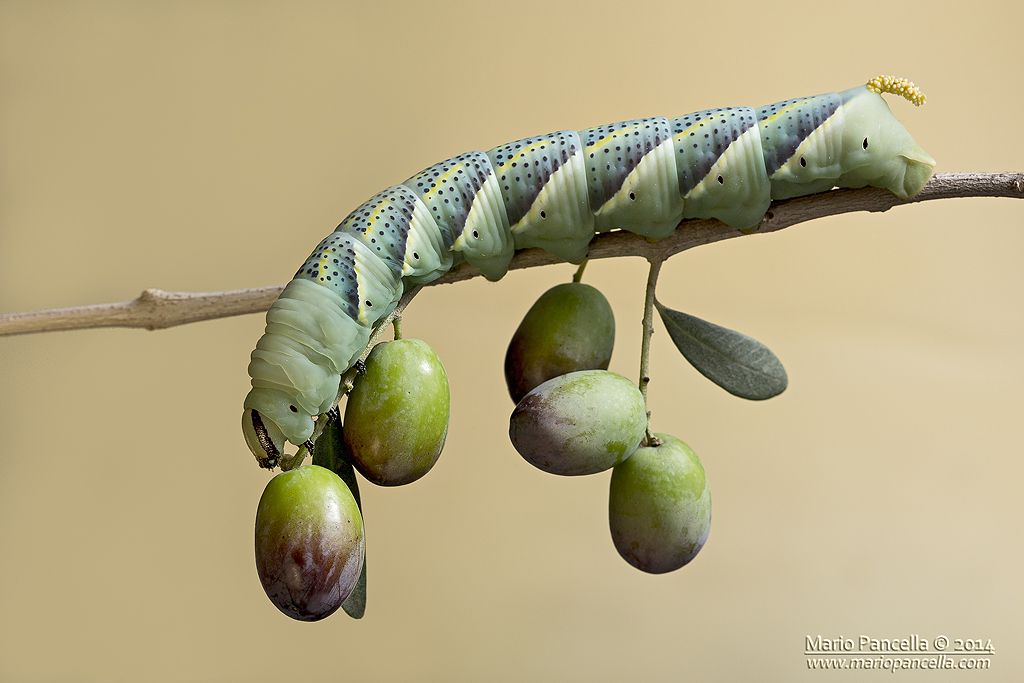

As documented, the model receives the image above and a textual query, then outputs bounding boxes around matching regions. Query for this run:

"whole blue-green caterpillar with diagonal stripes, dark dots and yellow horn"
[242,76,935,468]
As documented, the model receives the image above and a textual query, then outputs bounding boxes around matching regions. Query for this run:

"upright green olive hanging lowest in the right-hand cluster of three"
[608,434,711,573]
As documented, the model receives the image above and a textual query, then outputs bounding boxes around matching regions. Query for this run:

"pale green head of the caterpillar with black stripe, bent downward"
[242,388,315,469]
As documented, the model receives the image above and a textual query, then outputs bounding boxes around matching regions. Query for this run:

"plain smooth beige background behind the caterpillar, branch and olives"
[0,2,1024,681]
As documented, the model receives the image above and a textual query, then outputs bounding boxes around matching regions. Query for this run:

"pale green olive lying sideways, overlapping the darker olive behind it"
[509,370,647,475]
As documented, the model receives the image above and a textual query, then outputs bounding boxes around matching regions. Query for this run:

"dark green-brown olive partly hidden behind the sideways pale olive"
[505,283,615,402]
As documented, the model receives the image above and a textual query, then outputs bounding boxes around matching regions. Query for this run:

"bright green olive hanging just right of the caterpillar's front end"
[345,339,451,486]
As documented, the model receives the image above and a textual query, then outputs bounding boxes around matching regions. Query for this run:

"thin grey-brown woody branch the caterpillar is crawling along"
[0,172,1024,337]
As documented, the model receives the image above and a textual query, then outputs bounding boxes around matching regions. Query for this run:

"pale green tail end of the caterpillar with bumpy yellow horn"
[837,76,935,199]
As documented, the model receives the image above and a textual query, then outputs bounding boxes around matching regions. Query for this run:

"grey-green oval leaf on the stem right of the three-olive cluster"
[654,301,788,400]
